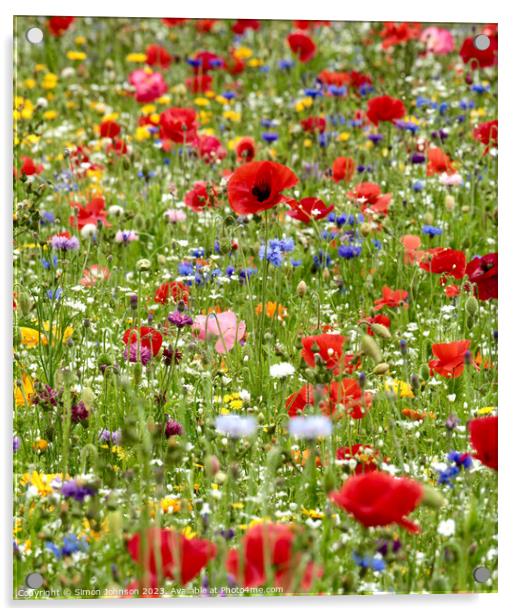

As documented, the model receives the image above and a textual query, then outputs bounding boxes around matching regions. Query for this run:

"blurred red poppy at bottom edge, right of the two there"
[226,523,321,593]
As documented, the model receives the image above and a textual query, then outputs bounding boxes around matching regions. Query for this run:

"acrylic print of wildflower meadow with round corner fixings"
[13,17,498,600]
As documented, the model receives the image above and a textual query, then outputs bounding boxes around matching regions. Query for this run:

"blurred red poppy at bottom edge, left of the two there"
[127,528,216,585]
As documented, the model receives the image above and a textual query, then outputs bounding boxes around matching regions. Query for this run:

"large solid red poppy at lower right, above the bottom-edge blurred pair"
[330,471,423,532]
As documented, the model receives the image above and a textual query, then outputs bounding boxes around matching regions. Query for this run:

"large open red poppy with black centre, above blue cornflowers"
[227,160,298,215]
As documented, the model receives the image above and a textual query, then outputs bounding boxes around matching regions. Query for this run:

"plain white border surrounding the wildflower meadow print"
[0,0,519,616]
